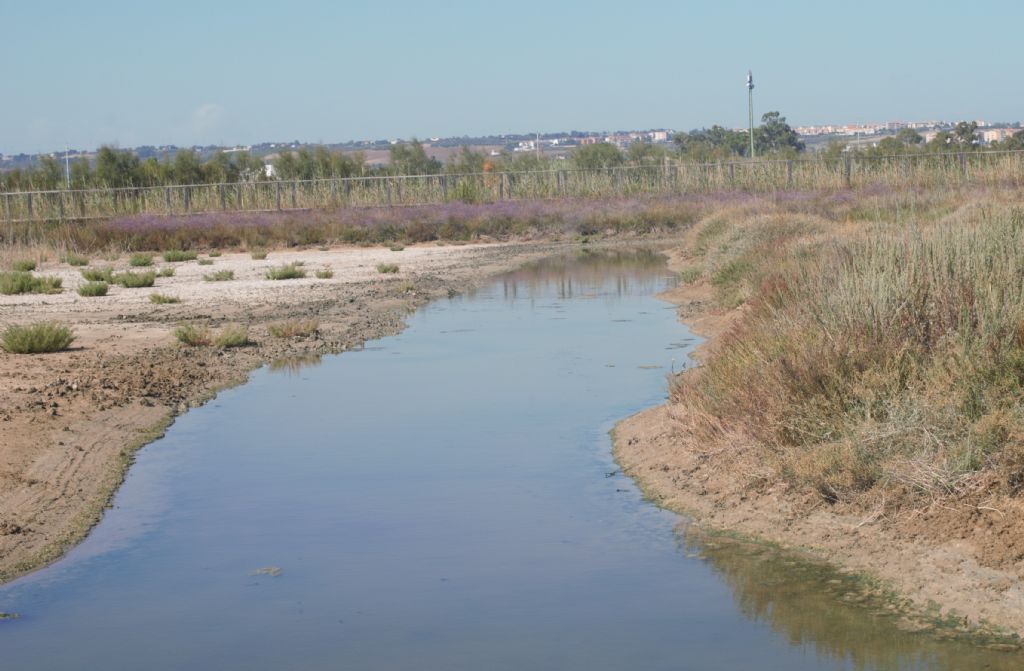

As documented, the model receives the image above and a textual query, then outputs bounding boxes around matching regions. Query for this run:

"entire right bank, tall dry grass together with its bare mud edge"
[614,186,1024,634]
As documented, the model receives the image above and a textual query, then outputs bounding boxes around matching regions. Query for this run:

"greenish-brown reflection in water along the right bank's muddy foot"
[676,522,1024,671]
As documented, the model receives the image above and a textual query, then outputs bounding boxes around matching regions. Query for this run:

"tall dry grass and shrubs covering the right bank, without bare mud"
[672,191,1024,501]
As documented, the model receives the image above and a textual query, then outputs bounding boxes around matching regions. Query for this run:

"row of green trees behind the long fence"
[0,112,1024,192]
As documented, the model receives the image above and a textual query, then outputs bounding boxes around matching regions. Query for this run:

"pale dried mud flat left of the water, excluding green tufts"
[0,243,569,582]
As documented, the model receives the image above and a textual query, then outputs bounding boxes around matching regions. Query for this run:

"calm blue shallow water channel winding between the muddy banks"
[0,248,1021,671]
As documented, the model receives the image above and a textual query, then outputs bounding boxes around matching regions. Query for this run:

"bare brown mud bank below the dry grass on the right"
[613,247,1024,635]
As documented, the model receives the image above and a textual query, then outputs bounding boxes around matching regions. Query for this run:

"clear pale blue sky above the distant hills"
[0,0,1024,154]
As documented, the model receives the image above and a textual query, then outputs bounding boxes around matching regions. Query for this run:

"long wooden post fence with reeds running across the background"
[0,152,1024,223]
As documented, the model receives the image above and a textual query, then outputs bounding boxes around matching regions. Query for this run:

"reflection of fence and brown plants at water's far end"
[502,249,671,300]
